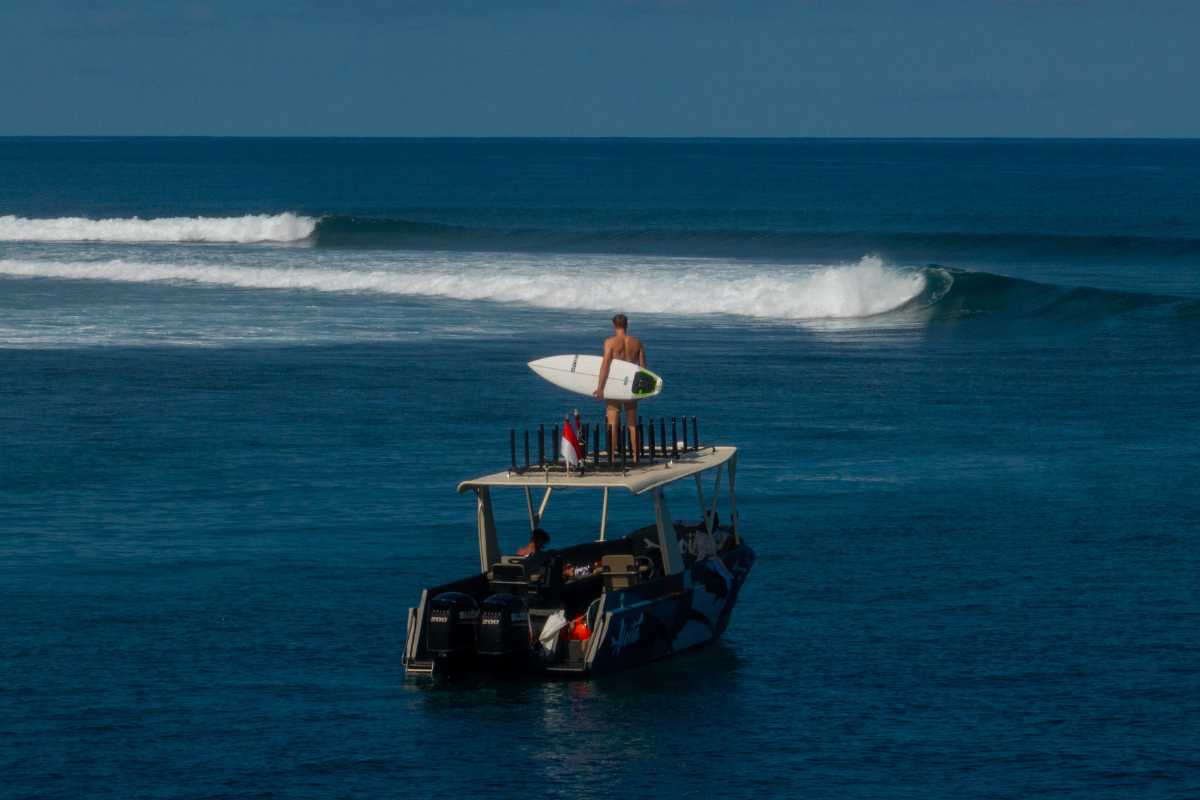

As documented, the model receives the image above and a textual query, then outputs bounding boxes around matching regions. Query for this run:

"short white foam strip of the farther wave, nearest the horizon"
[0,212,317,243]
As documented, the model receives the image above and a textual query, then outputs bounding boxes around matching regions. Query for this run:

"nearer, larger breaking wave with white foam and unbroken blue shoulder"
[0,253,1200,327]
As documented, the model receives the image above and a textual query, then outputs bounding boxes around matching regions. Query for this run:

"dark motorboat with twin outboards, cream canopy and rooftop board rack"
[403,417,755,678]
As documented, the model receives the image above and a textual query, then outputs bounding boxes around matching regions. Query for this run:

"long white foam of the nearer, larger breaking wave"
[0,257,925,319]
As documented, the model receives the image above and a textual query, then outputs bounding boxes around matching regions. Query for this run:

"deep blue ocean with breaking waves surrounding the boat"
[0,139,1200,800]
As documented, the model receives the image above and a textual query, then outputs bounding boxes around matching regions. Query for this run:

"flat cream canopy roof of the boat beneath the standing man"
[458,445,738,494]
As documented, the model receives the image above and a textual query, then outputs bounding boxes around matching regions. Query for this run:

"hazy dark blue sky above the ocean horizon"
[0,0,1200,137]
